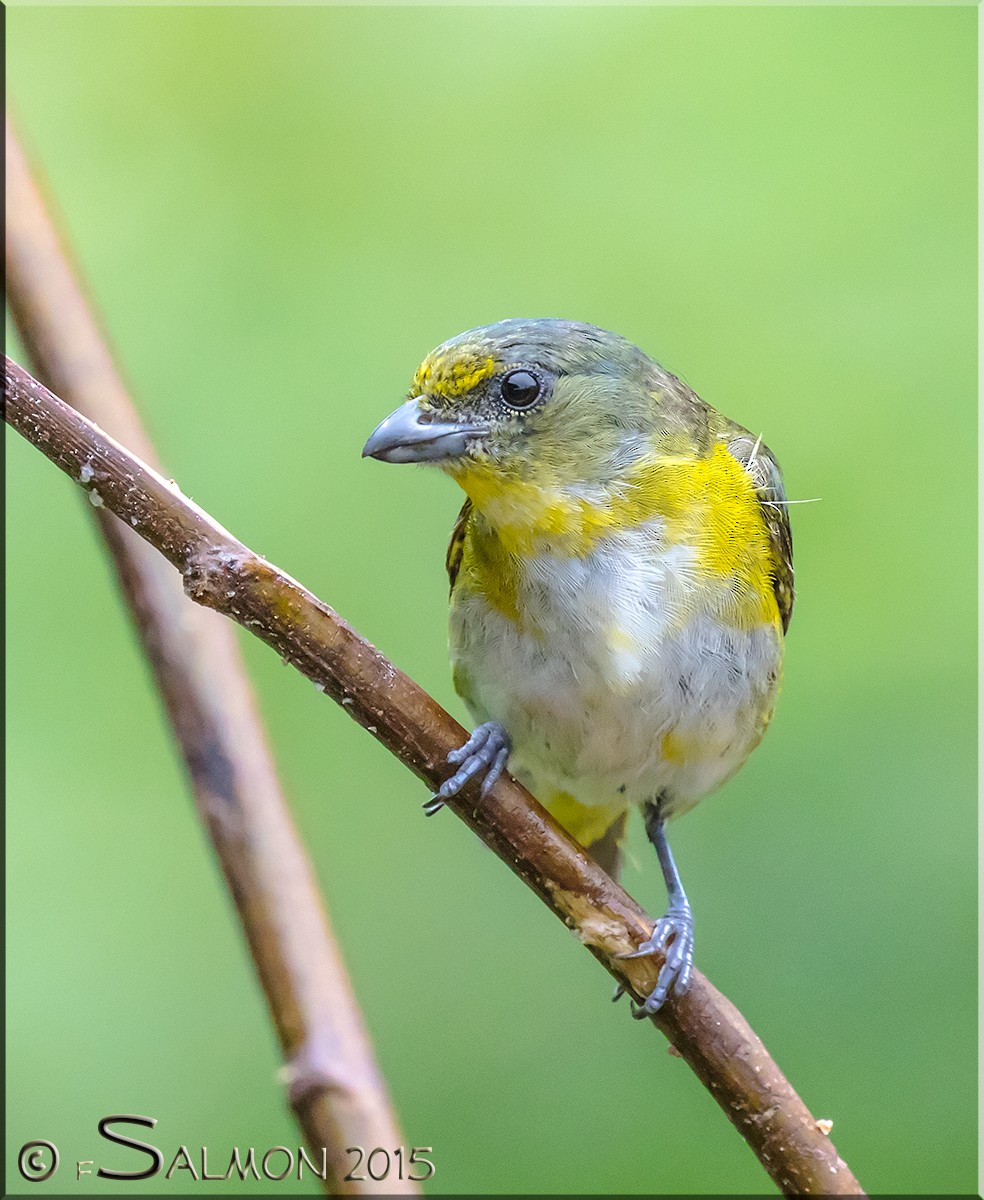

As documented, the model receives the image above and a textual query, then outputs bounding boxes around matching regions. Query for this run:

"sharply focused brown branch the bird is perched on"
[6,360,863,1195]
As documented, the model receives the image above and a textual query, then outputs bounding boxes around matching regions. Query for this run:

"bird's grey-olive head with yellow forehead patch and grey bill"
[362,318,679,494]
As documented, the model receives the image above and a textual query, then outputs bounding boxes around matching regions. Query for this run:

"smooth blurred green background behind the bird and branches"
[6,7,977,1195]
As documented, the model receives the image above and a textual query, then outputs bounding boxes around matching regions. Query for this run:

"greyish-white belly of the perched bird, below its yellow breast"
[451,529,781,814]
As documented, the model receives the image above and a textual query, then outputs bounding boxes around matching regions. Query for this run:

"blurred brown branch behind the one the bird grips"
[6,117,419,1194]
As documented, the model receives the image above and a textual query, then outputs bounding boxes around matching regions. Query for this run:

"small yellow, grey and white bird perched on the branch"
[362,318,793,1018]
